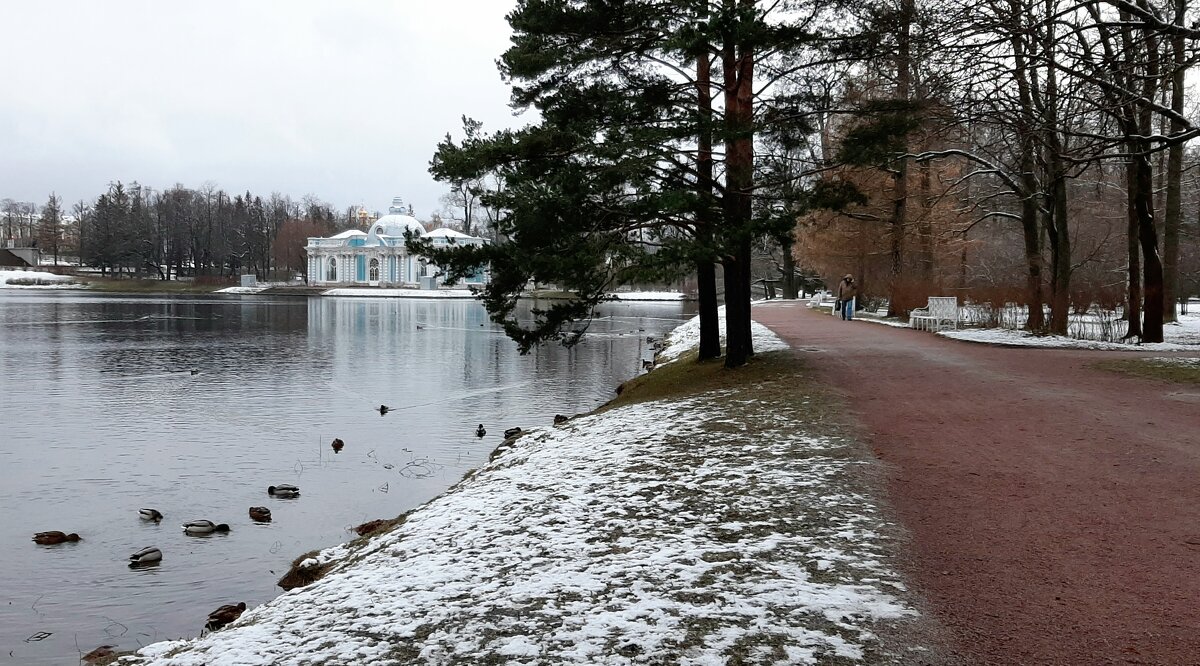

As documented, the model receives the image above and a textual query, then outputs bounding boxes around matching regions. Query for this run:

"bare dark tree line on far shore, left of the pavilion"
[0,182,408,280]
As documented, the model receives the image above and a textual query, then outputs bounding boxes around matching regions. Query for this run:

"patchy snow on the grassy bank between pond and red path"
[122,314,916,666]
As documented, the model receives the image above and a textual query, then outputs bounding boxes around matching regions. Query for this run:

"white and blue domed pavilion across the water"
[305,198,487,287]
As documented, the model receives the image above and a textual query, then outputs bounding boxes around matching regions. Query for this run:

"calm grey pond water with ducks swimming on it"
[0,289,694,665]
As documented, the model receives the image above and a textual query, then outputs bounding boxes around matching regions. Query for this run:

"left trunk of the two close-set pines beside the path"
[696,52,721,361]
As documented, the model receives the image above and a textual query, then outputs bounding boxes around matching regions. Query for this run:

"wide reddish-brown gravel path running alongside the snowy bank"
[754,301,1200,666]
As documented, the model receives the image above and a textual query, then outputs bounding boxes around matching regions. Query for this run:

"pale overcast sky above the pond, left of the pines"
[0,0,524,218]
